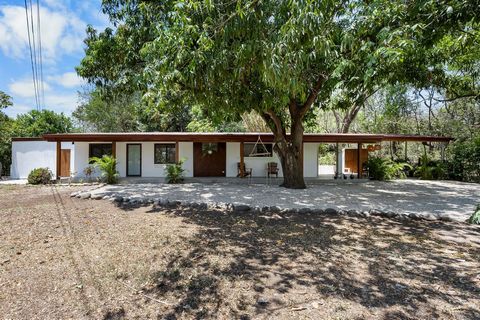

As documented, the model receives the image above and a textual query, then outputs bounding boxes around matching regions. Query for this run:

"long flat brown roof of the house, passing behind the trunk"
[38,132,453,143]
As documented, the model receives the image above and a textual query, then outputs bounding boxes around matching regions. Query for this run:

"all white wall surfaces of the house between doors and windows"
[12,141,319,178]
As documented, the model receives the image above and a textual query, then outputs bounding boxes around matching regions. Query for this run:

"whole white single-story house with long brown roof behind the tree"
[11,132,451,179]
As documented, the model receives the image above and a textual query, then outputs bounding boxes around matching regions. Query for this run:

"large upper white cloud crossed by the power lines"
[0,5,86,63]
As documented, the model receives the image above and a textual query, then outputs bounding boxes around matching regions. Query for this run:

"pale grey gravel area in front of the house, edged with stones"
[92,179,480,221]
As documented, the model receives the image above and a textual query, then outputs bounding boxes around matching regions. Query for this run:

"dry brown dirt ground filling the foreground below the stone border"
[0,186,480,319]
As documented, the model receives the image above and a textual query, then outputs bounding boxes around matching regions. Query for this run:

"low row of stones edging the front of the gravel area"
[70,190,454,222]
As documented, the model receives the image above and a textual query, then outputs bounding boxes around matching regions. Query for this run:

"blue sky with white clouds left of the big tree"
[0,0,109,117]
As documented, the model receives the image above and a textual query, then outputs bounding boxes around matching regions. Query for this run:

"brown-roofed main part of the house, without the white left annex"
[43,132,451,183]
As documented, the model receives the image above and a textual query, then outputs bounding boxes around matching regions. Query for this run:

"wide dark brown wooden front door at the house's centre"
[193,142,227,177]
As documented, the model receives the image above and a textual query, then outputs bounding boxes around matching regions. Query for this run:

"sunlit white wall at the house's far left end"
[10,141,75,179]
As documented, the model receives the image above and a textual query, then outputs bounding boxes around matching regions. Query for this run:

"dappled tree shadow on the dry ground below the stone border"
[120,207,480,319]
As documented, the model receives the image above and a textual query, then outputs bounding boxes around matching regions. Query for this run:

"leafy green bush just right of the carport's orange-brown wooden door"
[366,157,411,181]
